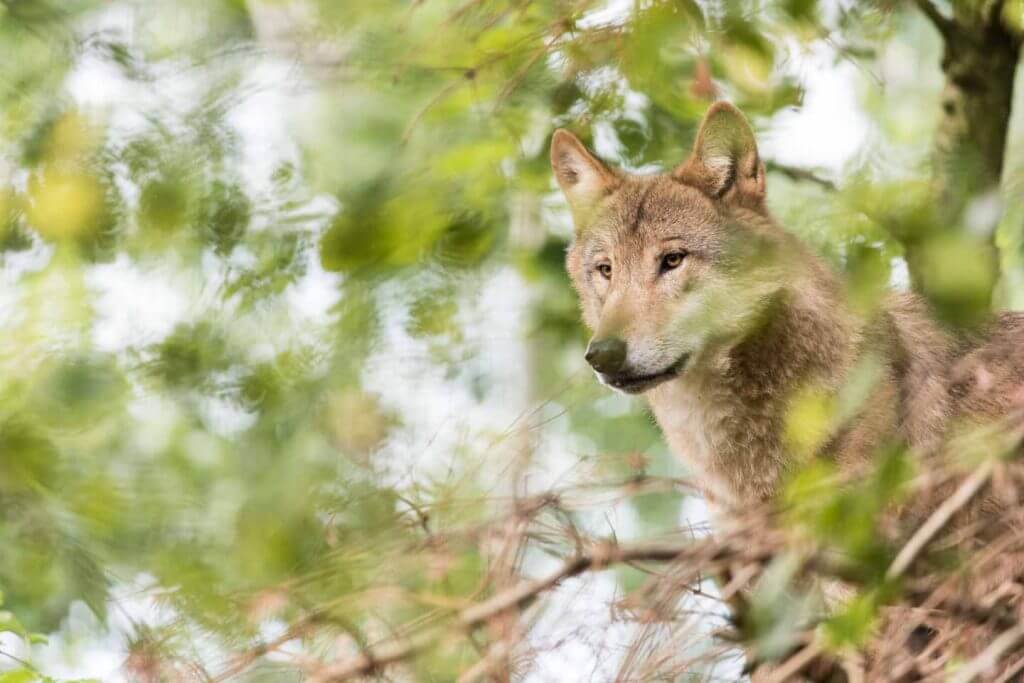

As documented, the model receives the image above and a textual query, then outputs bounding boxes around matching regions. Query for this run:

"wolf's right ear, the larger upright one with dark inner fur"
[672,101,765,210]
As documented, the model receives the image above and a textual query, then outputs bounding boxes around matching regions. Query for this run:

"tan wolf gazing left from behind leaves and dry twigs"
[551,101,1024,675]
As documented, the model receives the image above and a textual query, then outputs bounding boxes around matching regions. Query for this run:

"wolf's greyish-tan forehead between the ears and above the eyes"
[577,175,725,251]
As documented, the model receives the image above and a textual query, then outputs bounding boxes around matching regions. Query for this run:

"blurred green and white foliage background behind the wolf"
[0,0,1024,683]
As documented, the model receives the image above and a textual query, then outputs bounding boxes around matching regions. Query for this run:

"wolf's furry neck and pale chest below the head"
[649,280,859,509]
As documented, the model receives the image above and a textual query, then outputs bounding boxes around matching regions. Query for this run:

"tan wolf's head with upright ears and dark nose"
[551,102,784,393]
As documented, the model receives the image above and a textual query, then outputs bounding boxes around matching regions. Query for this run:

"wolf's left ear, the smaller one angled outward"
[551,128,620,224]
